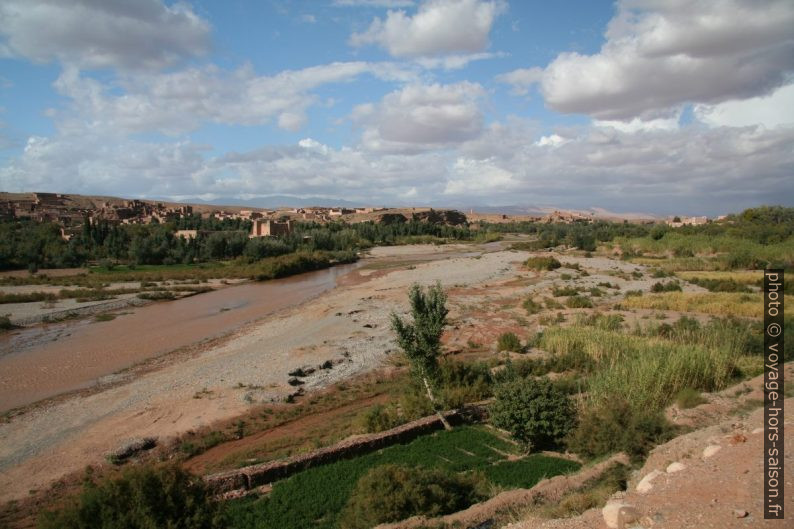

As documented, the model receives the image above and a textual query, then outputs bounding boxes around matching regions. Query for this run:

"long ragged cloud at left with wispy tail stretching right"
[54,62,413,135]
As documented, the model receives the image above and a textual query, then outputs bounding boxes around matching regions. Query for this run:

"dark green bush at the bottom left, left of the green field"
[39,465,222,529]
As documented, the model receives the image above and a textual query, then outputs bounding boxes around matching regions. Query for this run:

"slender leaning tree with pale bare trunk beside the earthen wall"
[391,283,450,430]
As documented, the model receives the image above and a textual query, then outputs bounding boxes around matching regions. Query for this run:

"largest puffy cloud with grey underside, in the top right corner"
[501,0,794,121]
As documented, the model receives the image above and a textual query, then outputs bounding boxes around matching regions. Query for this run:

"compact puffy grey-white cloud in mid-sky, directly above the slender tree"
[353,82,485,152]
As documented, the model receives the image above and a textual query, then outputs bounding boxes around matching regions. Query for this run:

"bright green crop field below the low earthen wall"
[220,426,579,529]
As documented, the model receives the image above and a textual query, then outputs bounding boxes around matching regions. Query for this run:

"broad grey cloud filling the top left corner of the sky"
[0,0,211,69]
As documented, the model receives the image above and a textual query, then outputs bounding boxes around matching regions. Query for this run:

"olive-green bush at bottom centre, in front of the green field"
[340,464,485,529]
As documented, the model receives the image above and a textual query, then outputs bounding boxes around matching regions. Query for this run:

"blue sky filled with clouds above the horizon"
[0,0,794,216]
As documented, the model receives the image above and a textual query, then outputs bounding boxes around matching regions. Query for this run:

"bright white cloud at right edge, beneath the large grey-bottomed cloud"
[694,84,794,128]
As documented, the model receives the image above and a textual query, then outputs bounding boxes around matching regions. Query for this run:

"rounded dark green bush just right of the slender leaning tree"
[490,379,576,450]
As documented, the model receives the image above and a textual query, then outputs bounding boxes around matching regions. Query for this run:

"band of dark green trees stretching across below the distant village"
[0,206,794,269]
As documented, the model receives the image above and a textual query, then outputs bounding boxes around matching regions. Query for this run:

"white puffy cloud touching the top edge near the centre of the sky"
[350,0,504,57]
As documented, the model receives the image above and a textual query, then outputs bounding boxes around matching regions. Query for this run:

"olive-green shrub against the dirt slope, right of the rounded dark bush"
[566,400,673,460]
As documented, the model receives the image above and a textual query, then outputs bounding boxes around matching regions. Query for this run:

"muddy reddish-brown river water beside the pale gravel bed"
[0,262,361,412]
